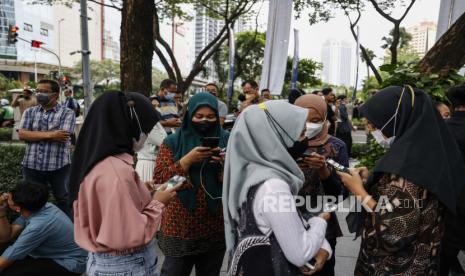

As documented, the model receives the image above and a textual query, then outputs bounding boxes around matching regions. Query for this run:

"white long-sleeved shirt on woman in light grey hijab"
[253,179,332,267]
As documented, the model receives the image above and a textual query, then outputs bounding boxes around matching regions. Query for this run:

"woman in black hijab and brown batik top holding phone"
[339,86,465,275]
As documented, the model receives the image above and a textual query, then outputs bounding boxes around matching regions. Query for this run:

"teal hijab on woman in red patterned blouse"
[165,93,229,213]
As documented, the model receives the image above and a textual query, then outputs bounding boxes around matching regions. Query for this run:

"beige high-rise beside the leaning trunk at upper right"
[407,21,437,56]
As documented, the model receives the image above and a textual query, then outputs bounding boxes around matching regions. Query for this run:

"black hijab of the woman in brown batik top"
[360,86,465,212]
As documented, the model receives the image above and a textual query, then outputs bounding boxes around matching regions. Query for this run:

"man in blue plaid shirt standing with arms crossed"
[19,80,76,218]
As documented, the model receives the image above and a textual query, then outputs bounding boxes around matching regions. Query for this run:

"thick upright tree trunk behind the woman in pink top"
[120,0,155,96]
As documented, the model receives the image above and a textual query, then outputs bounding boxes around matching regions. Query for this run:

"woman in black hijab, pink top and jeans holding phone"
[70,92,176,275]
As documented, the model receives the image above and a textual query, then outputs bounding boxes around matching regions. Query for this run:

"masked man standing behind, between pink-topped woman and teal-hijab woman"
[155,79,181,134]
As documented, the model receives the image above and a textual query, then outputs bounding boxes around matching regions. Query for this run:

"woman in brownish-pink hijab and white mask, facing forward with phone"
[294,94,349,275]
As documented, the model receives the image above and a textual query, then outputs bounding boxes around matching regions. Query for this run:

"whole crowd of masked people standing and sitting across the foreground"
[0,77,465,276]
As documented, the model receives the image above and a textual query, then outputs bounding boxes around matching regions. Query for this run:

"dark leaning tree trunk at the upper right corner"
[418,13,465,76]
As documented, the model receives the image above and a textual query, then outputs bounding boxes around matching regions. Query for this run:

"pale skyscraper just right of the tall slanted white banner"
[321,39,353,86]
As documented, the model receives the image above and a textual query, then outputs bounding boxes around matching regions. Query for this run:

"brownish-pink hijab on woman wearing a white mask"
[294,94,330,147]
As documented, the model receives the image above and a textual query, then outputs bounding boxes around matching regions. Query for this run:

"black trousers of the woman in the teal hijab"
[160,250,225,276]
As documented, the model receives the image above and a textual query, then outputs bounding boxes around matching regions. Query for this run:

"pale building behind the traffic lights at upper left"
[0,0,104,83]
